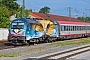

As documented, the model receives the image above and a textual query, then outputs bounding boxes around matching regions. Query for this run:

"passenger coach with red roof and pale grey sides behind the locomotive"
[57,21,90,39]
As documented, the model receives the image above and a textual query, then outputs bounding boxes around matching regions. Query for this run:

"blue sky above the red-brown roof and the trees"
[17,0,90,17]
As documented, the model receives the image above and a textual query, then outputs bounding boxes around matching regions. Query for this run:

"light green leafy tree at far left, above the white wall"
[0,6,10,28]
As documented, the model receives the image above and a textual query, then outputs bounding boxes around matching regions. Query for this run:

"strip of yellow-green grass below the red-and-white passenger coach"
[53,38,90,46]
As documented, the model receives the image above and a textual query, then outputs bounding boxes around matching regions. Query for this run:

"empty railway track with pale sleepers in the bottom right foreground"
[31,44,90,60]
